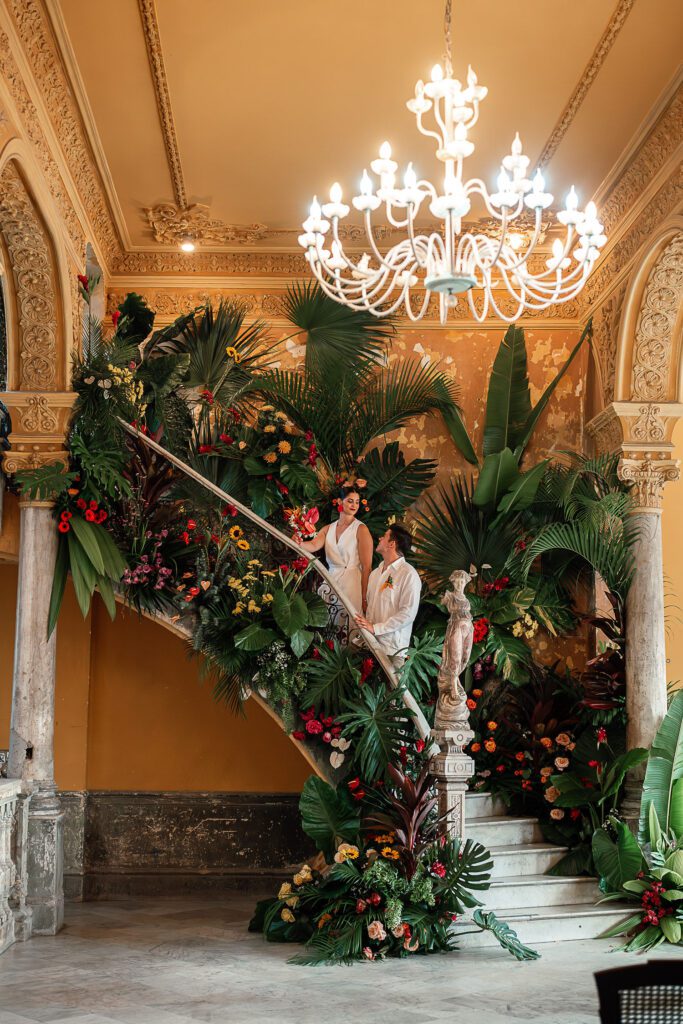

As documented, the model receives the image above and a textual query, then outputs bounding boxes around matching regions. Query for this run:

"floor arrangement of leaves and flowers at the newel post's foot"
[250,764,538,965]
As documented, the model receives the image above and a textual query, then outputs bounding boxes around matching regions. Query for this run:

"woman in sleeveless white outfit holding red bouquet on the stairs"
[301,484,373,626]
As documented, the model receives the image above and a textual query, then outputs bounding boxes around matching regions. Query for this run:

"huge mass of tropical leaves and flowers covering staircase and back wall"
[16,278,644,913]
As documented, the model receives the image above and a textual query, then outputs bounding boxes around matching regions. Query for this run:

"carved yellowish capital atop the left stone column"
[0,391,76,473]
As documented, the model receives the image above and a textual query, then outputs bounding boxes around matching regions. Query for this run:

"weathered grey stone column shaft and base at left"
[8,502,63,935]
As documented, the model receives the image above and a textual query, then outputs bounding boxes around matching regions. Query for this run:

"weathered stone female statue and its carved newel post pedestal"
[431,569,474,836]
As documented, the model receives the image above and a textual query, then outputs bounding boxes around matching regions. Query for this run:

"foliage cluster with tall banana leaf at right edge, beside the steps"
[593,691,683,952]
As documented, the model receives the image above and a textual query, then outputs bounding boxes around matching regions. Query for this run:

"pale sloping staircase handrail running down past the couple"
[119,418,438,753]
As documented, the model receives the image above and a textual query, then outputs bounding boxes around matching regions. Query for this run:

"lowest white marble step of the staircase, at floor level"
[454,903,632,948]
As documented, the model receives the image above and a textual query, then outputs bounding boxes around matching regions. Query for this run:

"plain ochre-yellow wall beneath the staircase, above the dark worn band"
[0,565,310,793]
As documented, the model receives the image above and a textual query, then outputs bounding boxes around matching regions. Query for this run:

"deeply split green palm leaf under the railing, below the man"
[339,686,409,781]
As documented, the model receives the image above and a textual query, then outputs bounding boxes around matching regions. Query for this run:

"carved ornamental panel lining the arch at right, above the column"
[631,231,683,401]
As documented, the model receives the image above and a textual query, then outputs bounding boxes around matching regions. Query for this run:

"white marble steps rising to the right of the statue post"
[463,793,626,946]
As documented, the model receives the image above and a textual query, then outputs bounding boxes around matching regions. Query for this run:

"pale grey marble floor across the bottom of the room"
[0,896,681,1024]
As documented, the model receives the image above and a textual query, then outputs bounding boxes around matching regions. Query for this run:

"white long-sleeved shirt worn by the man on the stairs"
[367,556,422,655]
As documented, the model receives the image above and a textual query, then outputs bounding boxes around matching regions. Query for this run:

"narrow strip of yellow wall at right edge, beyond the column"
[661,421,683,686]
